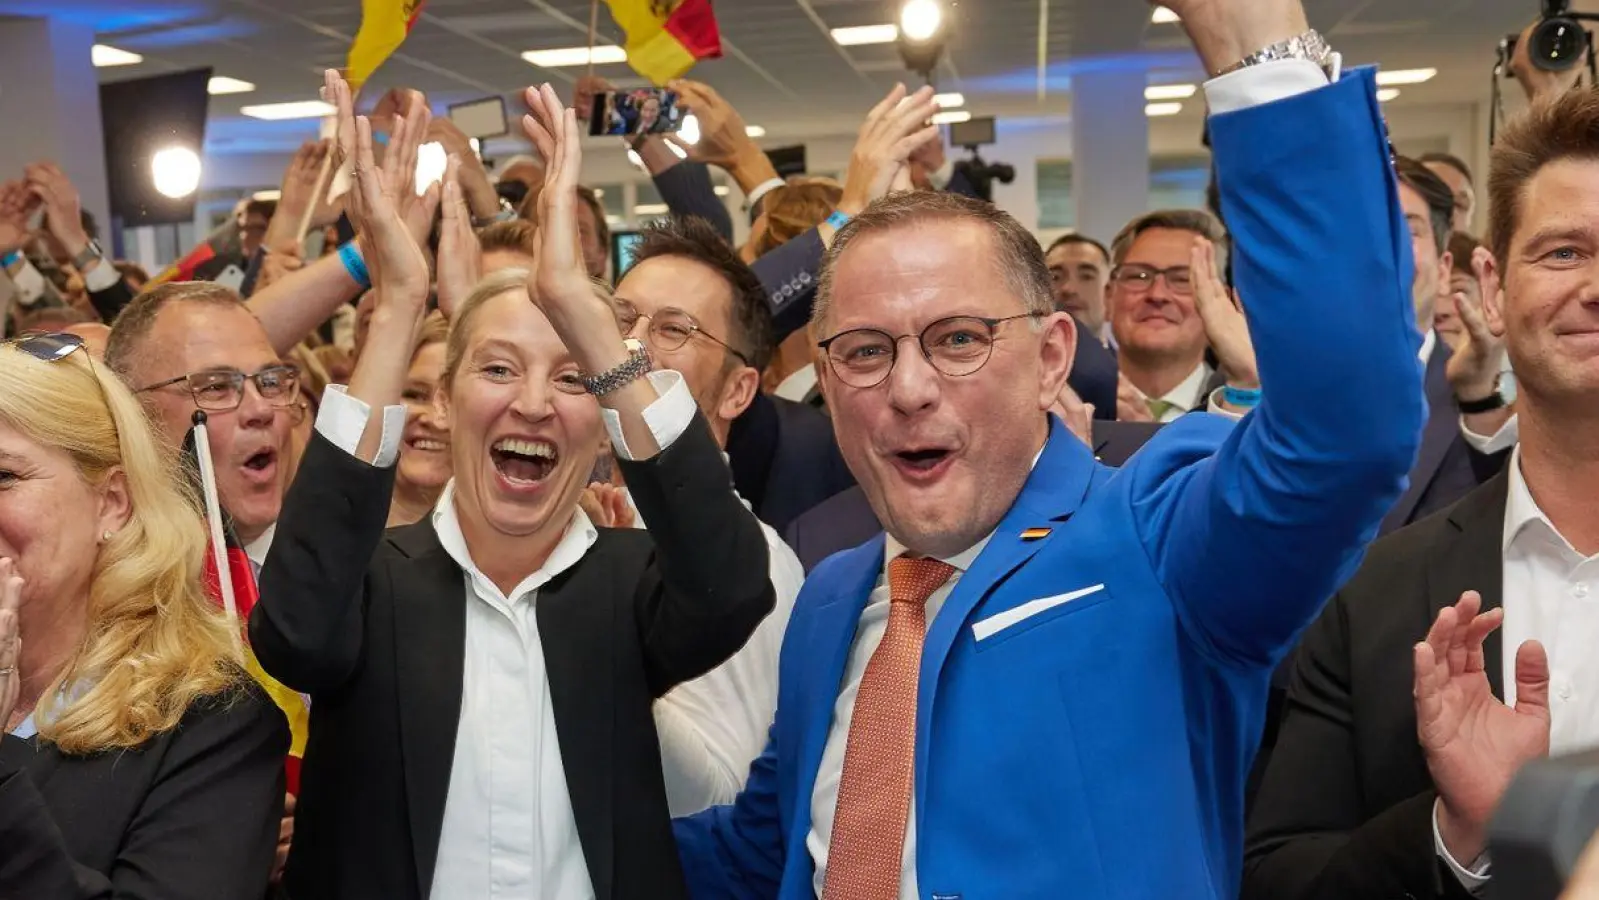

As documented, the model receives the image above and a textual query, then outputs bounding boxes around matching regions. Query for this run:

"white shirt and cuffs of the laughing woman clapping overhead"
[317,371,696,900]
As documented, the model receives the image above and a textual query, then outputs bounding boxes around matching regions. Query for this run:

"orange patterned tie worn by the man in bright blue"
[822,556,955,900]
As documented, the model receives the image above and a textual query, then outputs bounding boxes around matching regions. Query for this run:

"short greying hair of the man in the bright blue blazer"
[811,190,1055,337]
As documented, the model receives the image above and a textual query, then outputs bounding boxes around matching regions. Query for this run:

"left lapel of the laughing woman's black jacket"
[390,518,467,897]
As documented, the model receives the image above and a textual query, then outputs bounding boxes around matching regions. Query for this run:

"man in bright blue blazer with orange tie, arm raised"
[676,0,1423,900]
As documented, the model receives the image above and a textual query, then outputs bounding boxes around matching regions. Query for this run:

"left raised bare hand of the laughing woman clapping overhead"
[323,69,437,310]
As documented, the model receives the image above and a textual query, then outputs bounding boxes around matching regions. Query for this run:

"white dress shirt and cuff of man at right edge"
[1433,449,1599,894]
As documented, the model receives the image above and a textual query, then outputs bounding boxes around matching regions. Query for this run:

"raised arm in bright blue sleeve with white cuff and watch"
[1130,0,1425,667]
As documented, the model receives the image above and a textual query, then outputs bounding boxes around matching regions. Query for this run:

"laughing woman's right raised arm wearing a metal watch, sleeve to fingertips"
[523,85,774,697]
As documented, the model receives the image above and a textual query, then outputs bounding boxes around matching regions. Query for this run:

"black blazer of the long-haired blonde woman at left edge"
[0,684,289,900]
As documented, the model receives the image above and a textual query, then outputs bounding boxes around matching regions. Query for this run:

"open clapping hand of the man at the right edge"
[1415,591,1549,865]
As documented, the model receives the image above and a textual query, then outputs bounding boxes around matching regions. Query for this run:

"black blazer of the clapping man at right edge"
[1242,475,1509,900]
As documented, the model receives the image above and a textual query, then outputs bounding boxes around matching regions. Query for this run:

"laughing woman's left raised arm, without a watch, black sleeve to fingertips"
[249,72,429,691]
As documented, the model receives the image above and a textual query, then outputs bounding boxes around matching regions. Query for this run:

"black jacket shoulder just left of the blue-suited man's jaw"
[728,393,855,532]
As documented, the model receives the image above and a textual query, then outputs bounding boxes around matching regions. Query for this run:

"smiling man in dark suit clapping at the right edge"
[1242,90,1599,900]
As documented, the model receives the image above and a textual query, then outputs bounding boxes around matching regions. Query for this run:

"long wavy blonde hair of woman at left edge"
[0,347,243,756]
